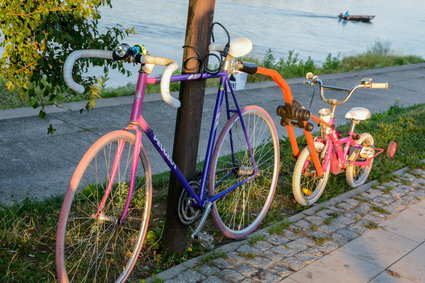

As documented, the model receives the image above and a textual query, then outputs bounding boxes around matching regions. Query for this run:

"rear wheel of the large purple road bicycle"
[208,106,280,239]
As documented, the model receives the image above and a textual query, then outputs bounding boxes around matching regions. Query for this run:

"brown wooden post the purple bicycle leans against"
[163,0,215,255]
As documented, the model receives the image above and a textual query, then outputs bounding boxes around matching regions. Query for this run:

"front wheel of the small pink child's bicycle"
[292,142,330,206]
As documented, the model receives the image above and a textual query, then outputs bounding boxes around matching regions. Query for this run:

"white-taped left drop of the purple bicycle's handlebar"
[63,49,112,93]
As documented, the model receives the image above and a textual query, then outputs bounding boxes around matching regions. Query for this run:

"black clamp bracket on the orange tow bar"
[276,100,313,131]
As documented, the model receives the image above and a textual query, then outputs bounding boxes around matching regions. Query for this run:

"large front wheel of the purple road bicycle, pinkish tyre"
[56,130,152,282]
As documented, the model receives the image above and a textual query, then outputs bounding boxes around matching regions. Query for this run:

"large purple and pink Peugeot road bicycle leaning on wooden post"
[56,38,280,282]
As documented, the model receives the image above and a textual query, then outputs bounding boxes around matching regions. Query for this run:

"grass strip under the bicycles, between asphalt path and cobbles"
[0,104,425,282]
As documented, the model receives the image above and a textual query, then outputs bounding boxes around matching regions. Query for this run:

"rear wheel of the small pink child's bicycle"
[345,133,373,188]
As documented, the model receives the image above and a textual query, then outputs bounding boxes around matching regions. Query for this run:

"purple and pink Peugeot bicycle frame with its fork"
[121,71,258,221]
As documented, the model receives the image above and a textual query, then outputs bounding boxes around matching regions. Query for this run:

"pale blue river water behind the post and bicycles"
[101,0,425,86]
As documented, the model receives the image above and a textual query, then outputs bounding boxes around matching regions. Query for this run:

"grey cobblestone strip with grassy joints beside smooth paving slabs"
[147,168,425,283]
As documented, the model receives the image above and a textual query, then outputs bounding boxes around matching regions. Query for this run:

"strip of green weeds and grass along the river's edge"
[0,41,425,109]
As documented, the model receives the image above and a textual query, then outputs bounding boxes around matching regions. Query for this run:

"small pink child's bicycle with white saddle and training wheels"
[288,73,397,206]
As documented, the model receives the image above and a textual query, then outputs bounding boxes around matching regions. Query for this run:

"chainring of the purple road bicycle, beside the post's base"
[177,181,202,226]
